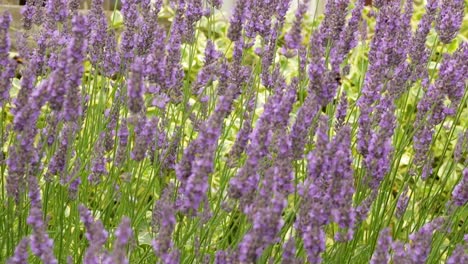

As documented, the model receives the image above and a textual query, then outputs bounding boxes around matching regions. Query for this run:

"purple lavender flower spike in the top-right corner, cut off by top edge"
[435,0,465,44]
